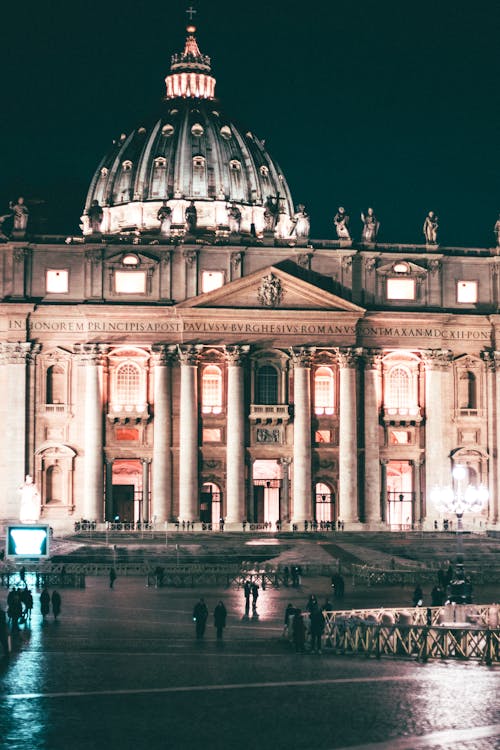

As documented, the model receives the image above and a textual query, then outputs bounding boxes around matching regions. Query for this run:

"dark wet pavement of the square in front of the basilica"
[0,578,500,750]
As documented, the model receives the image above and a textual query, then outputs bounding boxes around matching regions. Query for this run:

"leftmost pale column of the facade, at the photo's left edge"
[0,342,36,520]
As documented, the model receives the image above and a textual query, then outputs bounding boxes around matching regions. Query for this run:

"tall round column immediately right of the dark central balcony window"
[290,347,312,523]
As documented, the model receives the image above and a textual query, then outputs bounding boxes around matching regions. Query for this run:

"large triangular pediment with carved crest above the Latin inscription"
[177,266,365,314]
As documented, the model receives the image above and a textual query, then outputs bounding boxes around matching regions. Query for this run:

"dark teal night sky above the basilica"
[0,0,500,246]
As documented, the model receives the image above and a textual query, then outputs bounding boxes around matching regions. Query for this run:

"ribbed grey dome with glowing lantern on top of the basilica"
[82,26,293,241]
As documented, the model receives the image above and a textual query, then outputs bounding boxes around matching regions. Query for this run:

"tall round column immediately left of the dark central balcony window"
[225,346,249,523]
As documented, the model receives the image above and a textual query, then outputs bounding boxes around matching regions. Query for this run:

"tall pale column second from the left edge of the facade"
[77,344,108,521]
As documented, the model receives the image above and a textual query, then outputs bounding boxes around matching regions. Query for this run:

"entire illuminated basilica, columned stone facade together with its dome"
[0,26,500,530]
